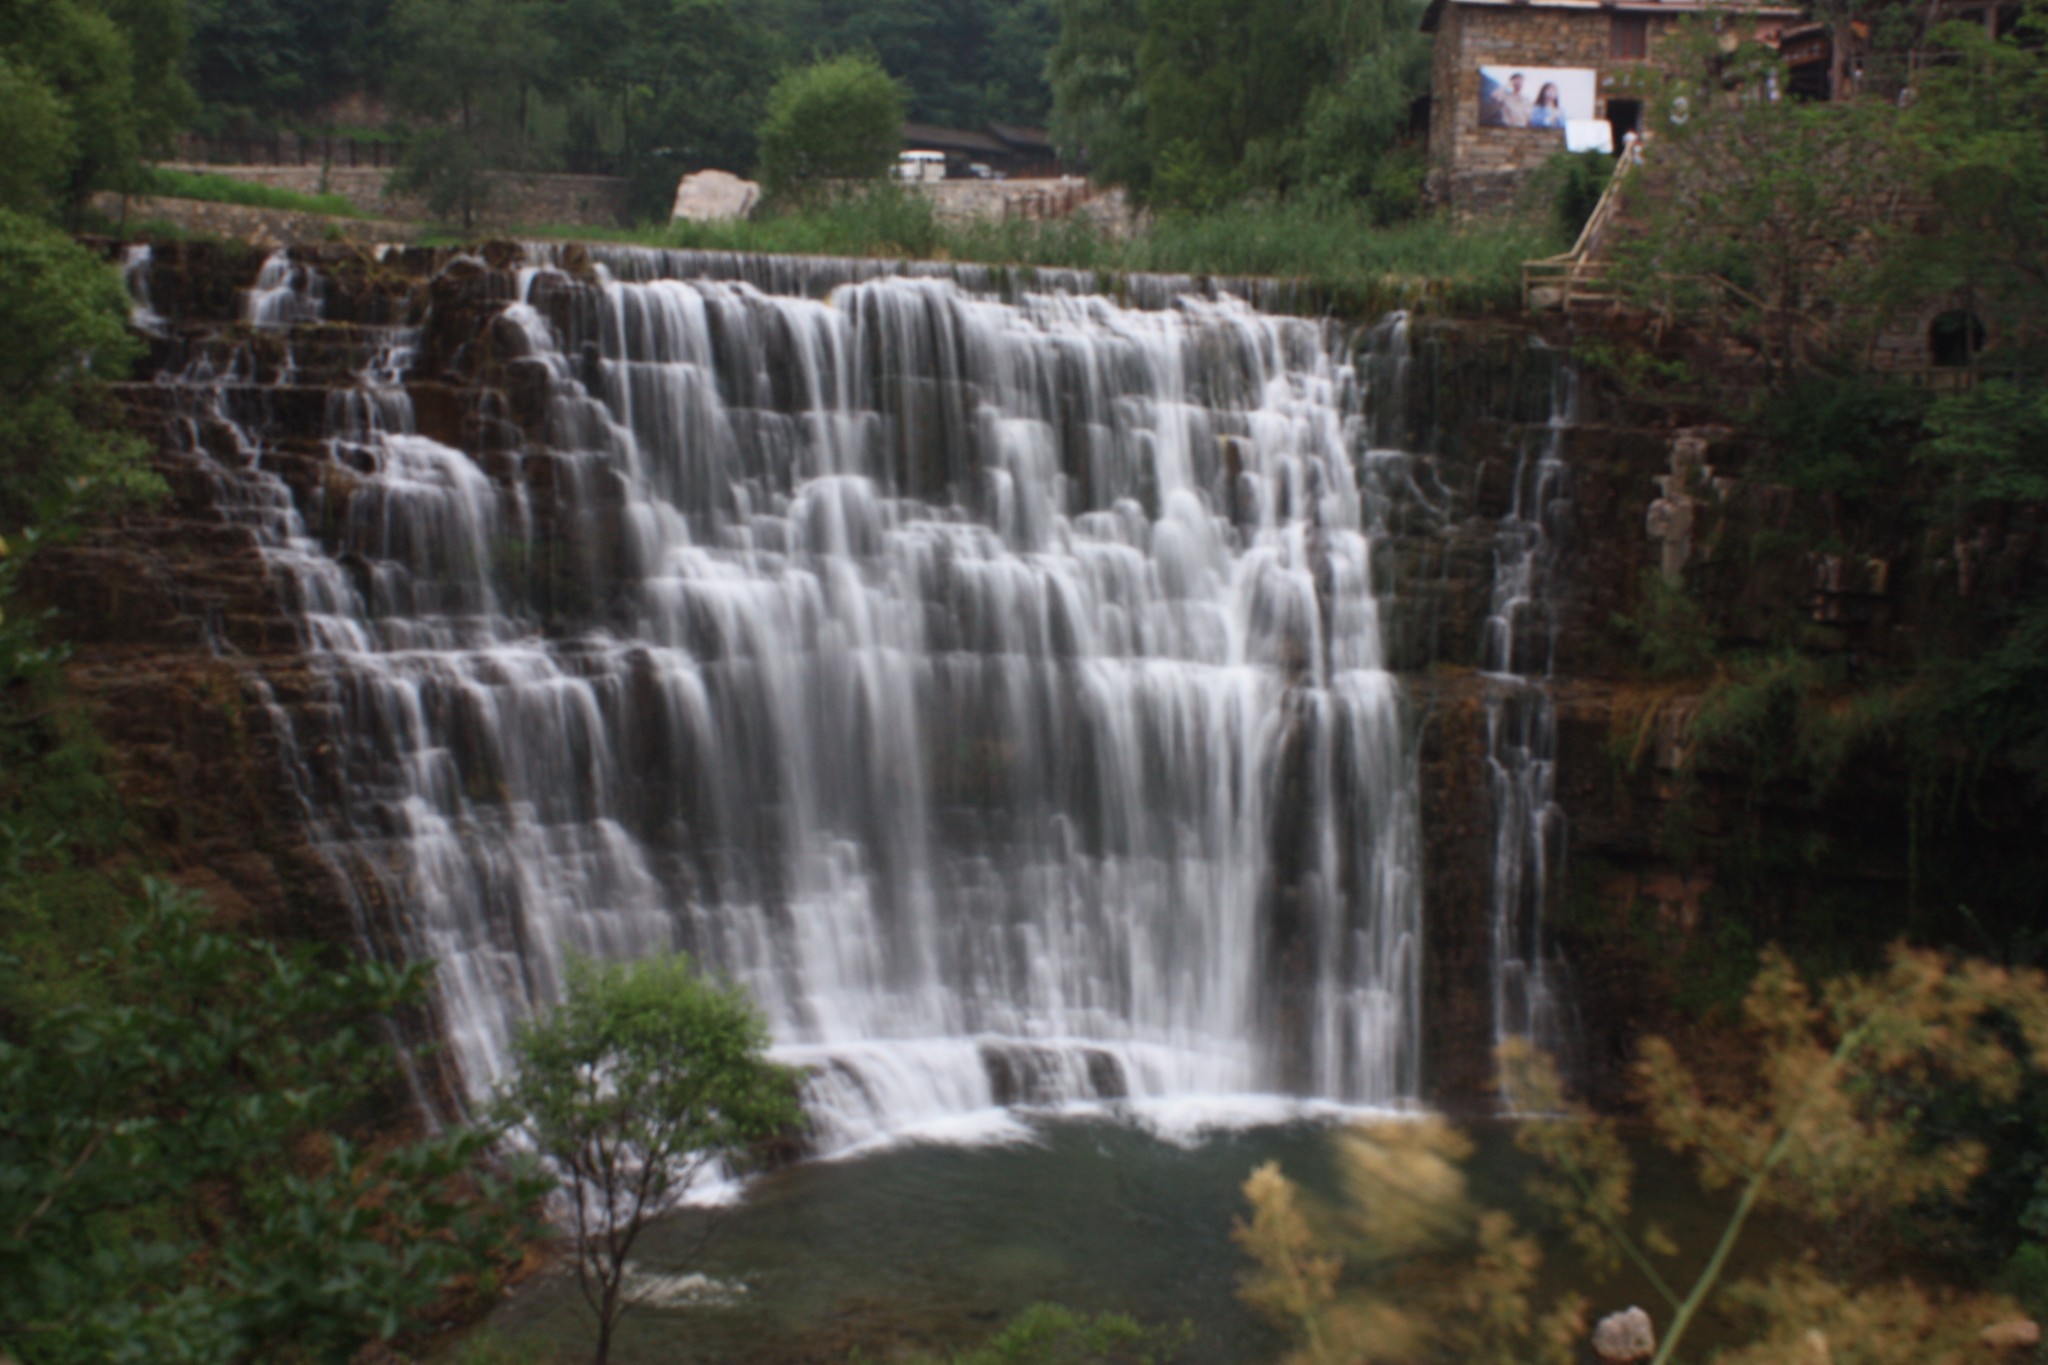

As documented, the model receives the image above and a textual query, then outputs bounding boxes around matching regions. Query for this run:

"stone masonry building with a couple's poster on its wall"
[1421,0,1802,217]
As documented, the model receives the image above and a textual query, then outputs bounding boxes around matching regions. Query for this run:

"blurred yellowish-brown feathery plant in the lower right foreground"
[1237,948,2048,1365]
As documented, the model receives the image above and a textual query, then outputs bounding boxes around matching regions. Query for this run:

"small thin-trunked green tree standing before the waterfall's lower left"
[502,954,799,1365]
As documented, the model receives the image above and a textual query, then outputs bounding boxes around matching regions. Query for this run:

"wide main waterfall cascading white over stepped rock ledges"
[148,250,1425,1150]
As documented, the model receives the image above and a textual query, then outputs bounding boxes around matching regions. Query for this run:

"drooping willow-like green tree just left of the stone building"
[1047,0,1430,208]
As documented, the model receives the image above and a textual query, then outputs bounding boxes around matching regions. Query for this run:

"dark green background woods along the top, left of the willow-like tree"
[186,0,1053,217]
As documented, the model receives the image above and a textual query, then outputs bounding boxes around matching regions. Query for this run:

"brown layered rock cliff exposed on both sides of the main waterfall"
[33,244,2040,1105]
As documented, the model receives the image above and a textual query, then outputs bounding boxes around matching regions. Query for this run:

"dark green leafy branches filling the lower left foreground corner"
[0,879,537,1365]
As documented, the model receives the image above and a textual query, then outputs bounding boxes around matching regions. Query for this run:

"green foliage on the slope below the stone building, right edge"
[1616,2,2048,385]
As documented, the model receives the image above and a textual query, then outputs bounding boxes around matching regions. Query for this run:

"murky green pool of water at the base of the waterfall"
[464,1113,1786,1365]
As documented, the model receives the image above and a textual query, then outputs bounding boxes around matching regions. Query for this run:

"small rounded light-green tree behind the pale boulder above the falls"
[760,55,903,194]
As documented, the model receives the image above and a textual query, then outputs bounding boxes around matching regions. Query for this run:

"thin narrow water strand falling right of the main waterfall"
[1481,366,1575,1107]
